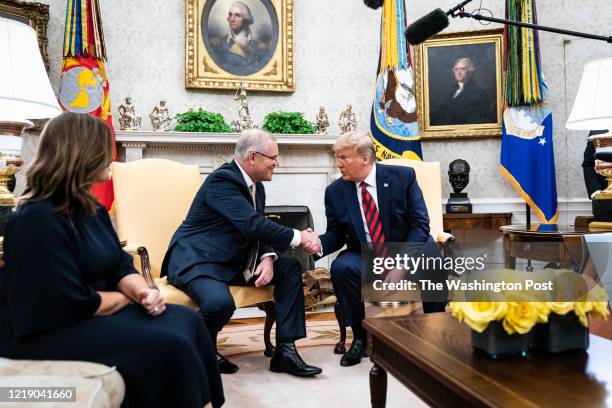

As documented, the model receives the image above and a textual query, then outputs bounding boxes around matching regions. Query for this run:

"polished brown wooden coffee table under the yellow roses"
[364,313,612,408]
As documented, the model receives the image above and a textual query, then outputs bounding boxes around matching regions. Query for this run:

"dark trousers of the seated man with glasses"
[180,256,306,344]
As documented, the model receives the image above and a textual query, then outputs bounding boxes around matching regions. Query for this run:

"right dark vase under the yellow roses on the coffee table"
[529,312,589,353]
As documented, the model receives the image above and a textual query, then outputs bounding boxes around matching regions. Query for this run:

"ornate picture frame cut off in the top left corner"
[0,0,49,72]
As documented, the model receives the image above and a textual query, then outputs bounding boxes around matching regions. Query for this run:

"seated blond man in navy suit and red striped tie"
[306,133,445,366]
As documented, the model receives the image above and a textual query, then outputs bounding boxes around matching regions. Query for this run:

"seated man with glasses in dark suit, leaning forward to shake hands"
[162,129,321,376]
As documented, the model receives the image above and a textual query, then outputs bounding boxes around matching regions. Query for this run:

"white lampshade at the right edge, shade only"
[565,58,612,130]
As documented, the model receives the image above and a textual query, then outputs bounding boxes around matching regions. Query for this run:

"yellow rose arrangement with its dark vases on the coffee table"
[449,270,609,358]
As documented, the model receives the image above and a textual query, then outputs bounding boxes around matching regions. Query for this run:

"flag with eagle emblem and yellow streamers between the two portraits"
[370,0,423,160]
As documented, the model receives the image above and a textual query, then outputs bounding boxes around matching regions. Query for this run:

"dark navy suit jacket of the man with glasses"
[162,161,293,286]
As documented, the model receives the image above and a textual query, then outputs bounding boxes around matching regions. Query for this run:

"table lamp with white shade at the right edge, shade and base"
[565,58,612,222]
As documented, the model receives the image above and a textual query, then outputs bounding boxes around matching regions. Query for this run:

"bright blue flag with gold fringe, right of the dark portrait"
[500,0,559,224]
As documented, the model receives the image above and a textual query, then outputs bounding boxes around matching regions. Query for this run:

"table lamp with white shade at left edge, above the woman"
[0,17,62,235]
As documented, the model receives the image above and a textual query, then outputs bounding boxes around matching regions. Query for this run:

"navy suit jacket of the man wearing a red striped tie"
[320,164,433,256]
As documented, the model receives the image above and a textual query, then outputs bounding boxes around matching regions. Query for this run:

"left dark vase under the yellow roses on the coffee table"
[472,321,529,358]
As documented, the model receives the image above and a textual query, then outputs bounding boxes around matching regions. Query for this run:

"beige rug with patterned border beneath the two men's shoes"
[217,321,427,408]
